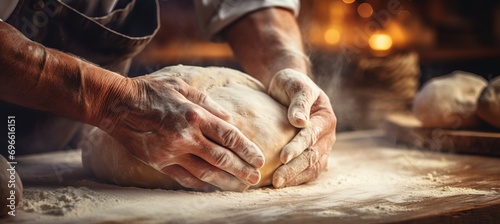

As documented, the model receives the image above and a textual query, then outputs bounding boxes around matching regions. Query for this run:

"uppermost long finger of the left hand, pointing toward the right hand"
[200,114,265,168]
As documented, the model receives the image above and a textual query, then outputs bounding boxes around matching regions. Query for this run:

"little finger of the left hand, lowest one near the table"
[161,165,217,192]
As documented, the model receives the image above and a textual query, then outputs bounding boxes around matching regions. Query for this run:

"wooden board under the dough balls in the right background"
[384,114,500,156]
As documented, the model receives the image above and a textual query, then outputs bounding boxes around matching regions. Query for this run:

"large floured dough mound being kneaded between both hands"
[82,65,297,189]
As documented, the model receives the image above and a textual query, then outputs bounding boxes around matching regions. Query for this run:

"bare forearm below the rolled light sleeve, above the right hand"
[223,8,310,87]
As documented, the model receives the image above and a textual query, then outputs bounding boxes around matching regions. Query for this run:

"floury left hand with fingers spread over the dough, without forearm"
[104,75,264,191]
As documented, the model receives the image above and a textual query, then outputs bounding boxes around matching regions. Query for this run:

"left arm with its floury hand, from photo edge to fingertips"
[0,22,258,190]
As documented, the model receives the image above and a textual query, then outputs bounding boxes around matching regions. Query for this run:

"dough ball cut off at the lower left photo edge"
[0,155,23,217]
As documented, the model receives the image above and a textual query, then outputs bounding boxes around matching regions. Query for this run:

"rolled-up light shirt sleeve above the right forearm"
[194,0,300,41]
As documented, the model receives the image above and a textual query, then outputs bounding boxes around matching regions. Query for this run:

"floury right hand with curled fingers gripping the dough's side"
[268,69,337,188]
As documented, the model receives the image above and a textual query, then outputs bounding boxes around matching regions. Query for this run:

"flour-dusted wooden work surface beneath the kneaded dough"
[0,131,500,223]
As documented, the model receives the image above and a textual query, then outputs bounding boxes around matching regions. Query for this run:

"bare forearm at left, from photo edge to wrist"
[0,22,131,126]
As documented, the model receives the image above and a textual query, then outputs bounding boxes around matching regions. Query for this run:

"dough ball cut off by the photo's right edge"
[476,76,500,128]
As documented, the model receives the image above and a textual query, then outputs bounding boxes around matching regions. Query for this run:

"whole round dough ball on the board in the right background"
[413,71,487,128]
